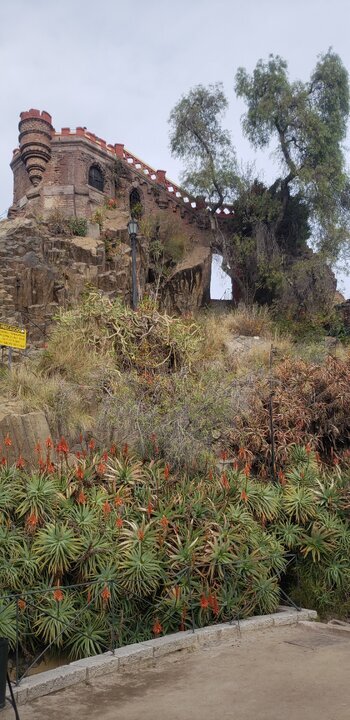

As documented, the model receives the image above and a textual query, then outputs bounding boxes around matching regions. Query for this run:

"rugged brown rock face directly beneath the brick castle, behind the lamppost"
[0,210,211,344]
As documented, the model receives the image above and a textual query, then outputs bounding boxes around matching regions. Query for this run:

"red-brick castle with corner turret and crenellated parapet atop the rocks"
[11,108,233,222]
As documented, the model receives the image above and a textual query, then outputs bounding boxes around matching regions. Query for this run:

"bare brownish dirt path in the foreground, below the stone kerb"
[0,625,350,720]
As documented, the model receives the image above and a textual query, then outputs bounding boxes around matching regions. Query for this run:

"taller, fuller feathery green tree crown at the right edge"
[235,50,350,259]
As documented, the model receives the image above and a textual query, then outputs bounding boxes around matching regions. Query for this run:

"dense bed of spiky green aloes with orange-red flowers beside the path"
[0,440,350,659]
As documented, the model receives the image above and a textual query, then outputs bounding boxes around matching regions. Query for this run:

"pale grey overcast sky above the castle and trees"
[0,0,350,295]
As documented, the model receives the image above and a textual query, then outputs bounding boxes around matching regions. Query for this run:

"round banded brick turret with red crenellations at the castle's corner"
[18,109,54,186]
